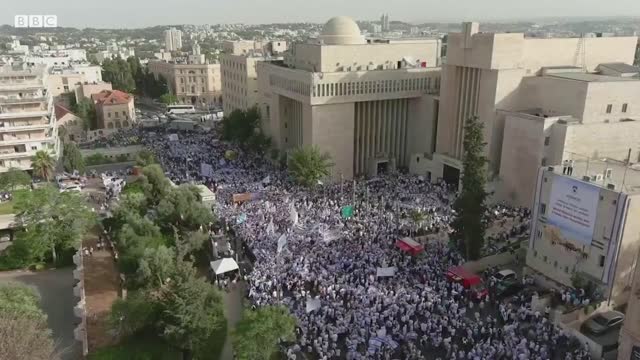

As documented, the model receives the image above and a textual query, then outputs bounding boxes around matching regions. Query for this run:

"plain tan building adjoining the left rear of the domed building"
[220,41,286,114]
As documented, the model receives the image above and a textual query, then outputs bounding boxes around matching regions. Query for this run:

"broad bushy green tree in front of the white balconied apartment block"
[14,185,95,263]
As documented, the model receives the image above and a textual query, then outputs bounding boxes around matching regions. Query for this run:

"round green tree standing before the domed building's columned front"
[287,146,333,187]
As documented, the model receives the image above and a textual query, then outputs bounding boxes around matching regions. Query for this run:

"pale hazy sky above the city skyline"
[0,0,640,28]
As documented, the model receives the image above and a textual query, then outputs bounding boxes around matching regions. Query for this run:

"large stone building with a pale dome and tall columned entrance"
[257,17,441,179]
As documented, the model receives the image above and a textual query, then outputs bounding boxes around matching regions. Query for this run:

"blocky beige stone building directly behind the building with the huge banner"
[496,64,640,206]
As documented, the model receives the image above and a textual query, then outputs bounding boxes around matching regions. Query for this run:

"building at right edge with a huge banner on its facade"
[527,167,640,307]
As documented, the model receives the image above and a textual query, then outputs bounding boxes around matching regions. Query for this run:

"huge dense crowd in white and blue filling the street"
[99,129,590,360]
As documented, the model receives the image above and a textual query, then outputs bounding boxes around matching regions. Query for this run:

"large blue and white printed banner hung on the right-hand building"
[546,176,600,245]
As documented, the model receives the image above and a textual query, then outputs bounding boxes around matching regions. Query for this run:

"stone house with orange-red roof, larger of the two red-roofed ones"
[91,90,136,129]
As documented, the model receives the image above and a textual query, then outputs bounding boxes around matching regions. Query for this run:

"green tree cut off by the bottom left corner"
[0,283,60,360]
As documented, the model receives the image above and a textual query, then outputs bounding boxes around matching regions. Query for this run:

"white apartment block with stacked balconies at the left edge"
[0,66,60,172]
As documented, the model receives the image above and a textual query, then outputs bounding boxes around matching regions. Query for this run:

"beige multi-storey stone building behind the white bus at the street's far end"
[148,60,222,108]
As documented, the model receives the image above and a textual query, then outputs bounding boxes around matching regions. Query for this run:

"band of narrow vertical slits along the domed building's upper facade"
[313,77,440,97]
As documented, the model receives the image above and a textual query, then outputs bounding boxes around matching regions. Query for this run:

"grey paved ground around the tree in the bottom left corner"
[0,267,81,360]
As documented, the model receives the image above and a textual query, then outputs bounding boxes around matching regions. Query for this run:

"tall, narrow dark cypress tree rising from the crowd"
[451,117,487,260]
